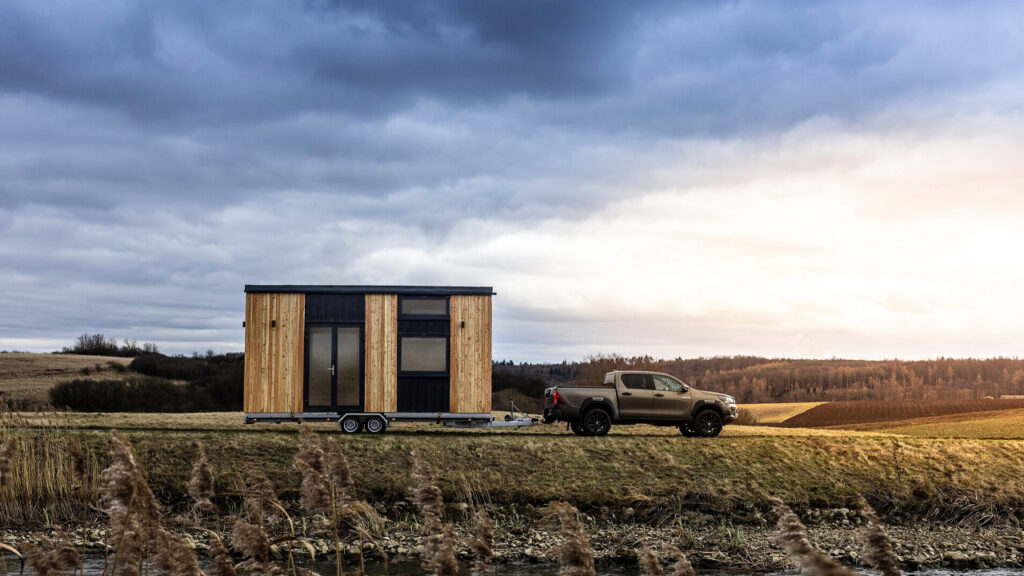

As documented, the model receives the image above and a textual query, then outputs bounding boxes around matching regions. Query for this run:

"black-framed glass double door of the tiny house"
[303,325,362,412]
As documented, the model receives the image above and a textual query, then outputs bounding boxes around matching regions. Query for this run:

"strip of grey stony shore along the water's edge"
[4,508,1024,572]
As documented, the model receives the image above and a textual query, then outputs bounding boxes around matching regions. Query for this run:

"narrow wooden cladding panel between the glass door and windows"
[364,294,398,412]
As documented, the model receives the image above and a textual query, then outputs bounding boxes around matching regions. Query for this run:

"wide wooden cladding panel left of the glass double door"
[243,293,305,413]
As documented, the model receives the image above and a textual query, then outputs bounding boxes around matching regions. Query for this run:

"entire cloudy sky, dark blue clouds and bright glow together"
[0,0,1024,361]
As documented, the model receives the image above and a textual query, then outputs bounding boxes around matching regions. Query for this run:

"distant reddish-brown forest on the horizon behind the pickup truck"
[494,356,1024,401]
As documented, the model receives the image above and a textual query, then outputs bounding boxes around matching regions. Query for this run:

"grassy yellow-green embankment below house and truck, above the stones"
[8,425,1024,529]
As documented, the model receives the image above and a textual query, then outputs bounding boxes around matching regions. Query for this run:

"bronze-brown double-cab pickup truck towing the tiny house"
[544,370,738,438]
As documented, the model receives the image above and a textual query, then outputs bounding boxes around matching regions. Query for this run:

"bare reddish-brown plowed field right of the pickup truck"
[780,399,1024,428]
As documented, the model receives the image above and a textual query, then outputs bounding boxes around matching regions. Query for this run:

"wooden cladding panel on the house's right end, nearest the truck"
[449,296,490,413]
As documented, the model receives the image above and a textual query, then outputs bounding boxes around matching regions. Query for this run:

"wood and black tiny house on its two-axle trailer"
[243,285,532,434]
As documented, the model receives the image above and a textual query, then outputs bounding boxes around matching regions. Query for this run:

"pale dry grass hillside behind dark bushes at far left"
[0,354,132,404]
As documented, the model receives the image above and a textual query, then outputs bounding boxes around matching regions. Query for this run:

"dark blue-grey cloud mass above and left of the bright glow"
[0,0,1024,348]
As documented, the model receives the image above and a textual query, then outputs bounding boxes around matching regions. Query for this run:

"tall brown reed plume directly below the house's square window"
[410,452,459,576]
